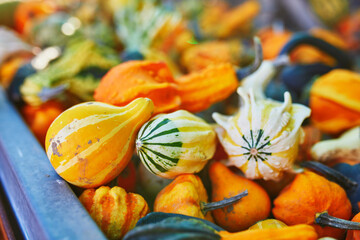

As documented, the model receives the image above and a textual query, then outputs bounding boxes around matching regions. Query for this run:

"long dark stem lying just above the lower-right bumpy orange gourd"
[300,161,358,189]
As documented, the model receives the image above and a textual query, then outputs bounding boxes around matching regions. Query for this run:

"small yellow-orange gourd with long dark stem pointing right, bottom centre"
[154,174,247,222]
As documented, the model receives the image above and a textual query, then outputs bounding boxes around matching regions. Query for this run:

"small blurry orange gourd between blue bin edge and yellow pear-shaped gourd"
[21,100,65,146]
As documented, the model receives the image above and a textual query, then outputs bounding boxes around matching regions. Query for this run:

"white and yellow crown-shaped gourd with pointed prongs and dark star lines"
[213,86,310,180]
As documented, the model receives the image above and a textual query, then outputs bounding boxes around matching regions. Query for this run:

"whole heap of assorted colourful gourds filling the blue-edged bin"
[0,0,360,240]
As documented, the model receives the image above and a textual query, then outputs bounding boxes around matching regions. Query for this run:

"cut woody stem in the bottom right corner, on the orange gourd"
[315,211,360,230]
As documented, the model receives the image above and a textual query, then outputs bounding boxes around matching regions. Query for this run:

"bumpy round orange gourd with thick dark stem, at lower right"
[272,171,354,239]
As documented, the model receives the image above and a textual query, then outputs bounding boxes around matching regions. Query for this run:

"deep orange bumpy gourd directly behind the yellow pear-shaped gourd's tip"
[94,61,180,113]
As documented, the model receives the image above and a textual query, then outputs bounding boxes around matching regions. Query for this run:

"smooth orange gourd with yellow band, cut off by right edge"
[310,69,360,134]
